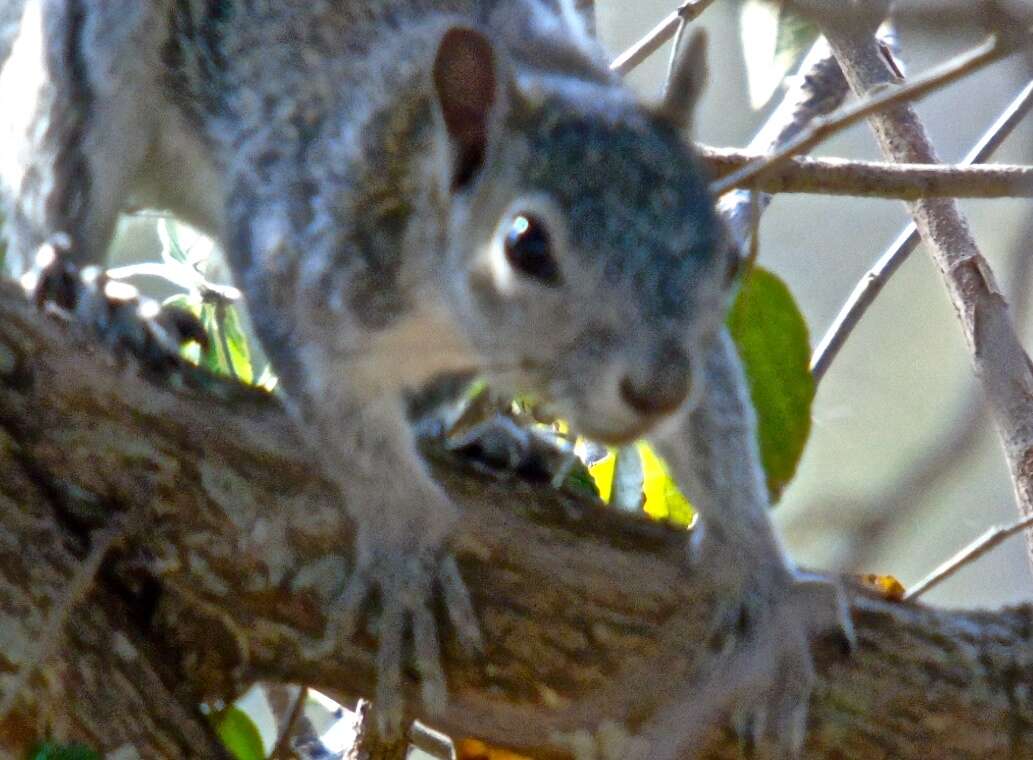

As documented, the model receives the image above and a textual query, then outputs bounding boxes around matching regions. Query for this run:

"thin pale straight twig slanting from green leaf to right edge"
[811,82,1033,383]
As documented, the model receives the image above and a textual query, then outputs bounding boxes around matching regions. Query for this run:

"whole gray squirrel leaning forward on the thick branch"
[0,0,849,757]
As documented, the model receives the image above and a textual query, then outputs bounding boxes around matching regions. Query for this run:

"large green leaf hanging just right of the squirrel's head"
[728,267,814,501]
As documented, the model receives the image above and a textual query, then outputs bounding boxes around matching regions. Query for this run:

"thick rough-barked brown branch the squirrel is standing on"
[0,286,1033,760]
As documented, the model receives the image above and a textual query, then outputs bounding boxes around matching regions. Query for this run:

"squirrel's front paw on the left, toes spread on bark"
[328,536,481,738]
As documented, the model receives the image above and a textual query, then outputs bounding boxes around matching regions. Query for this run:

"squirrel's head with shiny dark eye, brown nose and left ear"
[433,28,737,443]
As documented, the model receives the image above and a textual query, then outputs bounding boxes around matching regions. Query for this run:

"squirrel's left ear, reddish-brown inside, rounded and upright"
[434,27,498,188]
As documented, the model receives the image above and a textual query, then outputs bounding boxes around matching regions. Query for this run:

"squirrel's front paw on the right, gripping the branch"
[723,572,854,760]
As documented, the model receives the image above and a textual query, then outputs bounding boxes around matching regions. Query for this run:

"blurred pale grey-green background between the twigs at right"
[596,0,1033,607]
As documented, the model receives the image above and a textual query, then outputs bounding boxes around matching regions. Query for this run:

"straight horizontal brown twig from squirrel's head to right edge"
[698,146,1033,200]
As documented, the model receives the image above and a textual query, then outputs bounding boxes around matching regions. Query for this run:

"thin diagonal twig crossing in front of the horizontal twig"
[711,37,1014,195]
